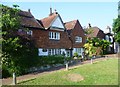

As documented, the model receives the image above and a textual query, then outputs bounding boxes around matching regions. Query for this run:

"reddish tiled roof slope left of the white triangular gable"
[40,13,59,29]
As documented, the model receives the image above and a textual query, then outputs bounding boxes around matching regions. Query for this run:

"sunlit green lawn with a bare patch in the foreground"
[19,58,118,85]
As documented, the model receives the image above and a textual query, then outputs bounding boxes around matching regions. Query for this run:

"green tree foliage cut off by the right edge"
[113,16,120,43]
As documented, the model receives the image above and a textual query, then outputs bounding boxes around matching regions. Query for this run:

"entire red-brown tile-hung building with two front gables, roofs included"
[18,10,85,56]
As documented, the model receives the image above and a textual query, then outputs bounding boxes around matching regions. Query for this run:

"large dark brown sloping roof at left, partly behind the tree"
[19,11,42,28]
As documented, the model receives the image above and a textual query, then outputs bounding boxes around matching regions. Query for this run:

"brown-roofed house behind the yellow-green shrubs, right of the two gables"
[85,24,105,39]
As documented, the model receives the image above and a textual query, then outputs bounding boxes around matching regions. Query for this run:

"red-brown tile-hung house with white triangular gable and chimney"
[33,8,71,56]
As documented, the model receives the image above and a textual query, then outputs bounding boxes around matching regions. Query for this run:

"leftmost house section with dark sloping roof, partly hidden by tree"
[18,9,42,38]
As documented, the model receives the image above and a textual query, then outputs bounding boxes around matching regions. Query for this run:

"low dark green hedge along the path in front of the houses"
[2,55,72,78]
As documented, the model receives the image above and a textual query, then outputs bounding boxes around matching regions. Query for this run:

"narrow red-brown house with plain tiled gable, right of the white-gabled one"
[65,20,85,55]
